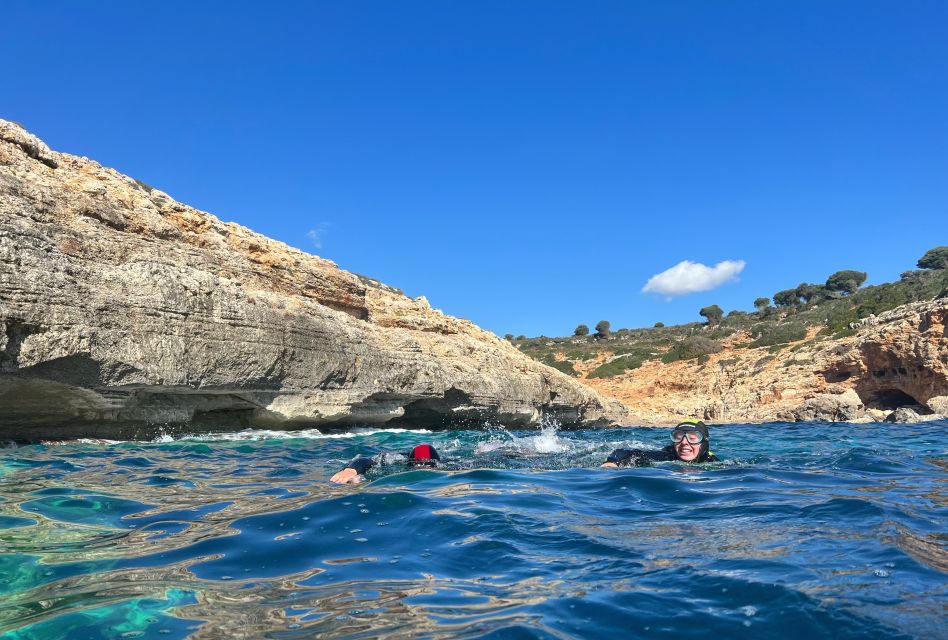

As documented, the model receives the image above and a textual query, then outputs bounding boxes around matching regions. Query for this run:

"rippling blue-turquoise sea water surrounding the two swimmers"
[0,422,948,640]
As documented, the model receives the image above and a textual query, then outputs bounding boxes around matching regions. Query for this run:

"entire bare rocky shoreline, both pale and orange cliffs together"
[0,120,948,441]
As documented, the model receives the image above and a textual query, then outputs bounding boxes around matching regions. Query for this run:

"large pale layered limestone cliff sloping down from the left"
[0,120,625,439]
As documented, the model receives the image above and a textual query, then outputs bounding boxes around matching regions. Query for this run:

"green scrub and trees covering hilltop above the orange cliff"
[514,247,948,378]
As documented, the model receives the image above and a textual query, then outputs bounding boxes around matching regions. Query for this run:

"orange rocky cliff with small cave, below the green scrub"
[585,299,948,422]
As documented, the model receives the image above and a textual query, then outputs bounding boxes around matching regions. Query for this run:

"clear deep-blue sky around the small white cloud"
[0,0,948,335]
